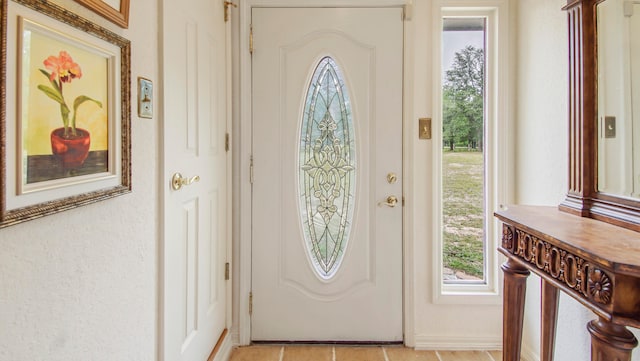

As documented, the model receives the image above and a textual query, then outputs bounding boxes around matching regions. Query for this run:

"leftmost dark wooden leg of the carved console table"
[501,259,531,361]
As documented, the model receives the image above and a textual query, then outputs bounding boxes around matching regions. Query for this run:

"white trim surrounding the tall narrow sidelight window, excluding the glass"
[432,0,513,304]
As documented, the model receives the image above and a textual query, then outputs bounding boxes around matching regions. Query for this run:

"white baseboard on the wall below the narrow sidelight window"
[415,335,502,351]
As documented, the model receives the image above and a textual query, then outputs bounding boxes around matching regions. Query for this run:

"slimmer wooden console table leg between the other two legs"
[540,279,558,361]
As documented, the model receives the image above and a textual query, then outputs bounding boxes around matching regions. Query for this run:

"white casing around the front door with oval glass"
[233,0,414,346]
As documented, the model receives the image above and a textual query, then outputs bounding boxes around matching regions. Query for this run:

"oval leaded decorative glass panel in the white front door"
[298,57,356,280]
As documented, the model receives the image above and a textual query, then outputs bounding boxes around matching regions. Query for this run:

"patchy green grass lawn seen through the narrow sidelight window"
[442,151,484,278]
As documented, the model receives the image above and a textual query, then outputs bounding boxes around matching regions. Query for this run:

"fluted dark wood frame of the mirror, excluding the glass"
[559,0,640,231]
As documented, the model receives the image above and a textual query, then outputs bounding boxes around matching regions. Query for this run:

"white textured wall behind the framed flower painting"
[0,0,160,361]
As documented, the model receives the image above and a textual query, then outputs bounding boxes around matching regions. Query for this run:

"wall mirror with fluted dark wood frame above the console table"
[560,0,640,231]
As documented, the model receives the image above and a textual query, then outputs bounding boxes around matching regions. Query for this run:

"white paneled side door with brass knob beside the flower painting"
[161,0,228,361]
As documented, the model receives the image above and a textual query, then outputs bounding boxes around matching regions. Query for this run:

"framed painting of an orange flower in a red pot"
[0,0,131,228]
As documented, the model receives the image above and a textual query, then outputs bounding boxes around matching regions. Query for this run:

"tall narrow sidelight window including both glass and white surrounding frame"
[433,6,513,303]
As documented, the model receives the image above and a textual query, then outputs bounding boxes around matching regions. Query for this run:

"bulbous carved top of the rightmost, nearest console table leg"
[587,318,638,361]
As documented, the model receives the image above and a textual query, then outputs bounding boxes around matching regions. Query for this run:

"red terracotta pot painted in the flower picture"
[51,128,91,168]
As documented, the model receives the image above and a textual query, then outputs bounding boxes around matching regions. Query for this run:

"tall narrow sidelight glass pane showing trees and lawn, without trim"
[442,17,487,283]
